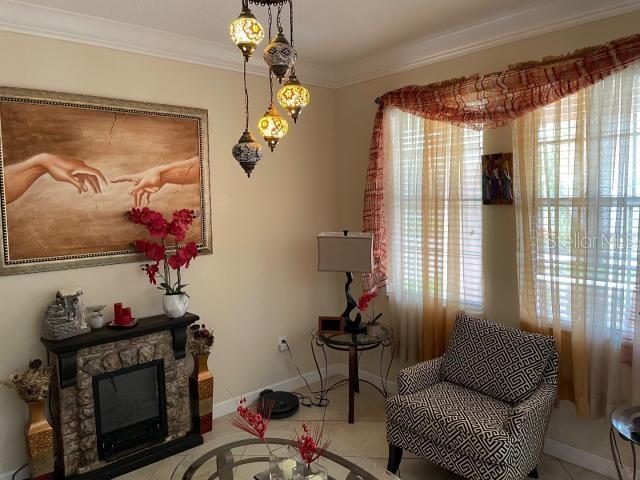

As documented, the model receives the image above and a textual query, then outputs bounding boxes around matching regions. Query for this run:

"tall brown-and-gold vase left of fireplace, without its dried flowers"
[25,400,53,480]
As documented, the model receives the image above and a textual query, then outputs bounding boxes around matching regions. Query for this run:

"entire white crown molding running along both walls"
[0,0,640,88]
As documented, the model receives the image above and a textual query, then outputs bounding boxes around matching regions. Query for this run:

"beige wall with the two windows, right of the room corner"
[337,12,640,464]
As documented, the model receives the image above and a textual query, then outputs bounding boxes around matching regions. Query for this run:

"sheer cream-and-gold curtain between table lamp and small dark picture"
[384,109,483,361]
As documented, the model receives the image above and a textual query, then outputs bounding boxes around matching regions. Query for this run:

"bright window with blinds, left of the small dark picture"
[386,110,483,312]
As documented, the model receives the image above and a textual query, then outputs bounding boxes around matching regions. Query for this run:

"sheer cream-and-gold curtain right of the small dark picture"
[513,63,640,417]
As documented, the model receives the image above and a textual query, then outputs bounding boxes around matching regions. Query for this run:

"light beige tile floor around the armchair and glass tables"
[119,379,605,480]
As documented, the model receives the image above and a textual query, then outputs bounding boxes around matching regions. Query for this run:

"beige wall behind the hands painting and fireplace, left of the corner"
[0,32,339,473]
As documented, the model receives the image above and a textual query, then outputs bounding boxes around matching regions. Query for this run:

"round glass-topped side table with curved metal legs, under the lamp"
[311,325,395,423]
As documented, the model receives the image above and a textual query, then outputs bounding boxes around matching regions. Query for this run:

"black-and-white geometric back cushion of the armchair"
[440,315,555,404]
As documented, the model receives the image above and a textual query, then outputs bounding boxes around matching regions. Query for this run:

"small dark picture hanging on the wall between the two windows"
[482,153,513,205]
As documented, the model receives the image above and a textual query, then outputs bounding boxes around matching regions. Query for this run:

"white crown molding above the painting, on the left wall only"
[0,0,334,88]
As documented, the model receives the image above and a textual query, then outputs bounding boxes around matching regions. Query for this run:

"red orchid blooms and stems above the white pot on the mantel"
[125,207,198,295]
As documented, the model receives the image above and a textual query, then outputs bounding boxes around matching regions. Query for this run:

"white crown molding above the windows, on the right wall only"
[334,0,640,88]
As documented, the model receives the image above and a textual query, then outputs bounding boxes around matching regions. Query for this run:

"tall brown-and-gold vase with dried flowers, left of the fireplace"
[1,359,54,480]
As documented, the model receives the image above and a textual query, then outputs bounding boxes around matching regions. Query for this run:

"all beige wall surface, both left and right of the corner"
[0,9,640,472]
